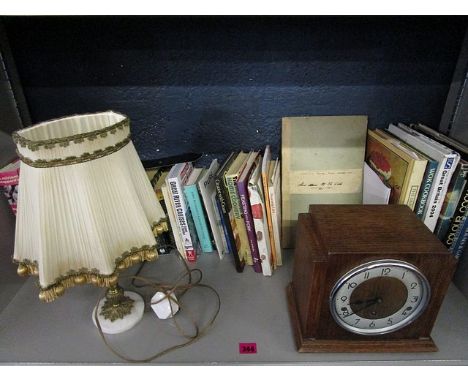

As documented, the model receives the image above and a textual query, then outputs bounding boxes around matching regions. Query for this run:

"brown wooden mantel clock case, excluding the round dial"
[287,205,456,352]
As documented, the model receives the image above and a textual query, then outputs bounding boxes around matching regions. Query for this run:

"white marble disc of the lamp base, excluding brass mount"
[93,291,145,334]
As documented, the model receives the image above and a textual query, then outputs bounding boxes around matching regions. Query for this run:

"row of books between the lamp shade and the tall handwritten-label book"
[151,146,282,276]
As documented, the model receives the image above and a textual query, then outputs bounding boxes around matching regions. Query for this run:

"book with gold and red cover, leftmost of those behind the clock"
[366,130,427,210]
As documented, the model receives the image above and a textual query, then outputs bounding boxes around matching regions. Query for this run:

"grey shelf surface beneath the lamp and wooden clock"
[0,252,468,365]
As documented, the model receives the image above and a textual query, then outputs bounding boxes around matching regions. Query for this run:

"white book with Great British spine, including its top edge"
[387,124,460,232]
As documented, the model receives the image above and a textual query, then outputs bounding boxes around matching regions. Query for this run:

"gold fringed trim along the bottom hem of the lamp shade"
[14,245,159,302]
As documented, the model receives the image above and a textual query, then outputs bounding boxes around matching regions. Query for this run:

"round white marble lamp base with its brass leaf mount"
[93,285,145,334]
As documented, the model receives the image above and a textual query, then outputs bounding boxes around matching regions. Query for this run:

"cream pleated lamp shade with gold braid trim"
[13,111,165,301]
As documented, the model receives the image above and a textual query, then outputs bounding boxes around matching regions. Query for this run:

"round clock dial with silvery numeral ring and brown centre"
[330,260,430,335]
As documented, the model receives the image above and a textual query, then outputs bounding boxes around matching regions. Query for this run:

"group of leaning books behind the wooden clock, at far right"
[365,123,468,258]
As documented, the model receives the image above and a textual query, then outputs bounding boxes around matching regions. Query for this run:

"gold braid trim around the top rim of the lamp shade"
[11,117,130,151]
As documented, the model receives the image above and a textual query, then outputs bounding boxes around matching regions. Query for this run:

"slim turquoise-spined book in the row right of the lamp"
[184,167,213,253]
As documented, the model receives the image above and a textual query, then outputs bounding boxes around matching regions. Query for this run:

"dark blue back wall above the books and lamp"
[3,17,467,159]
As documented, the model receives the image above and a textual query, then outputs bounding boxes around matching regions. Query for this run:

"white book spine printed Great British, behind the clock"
[424,155,457,232]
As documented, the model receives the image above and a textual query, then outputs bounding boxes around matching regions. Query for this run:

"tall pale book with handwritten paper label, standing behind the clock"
[281,116,367,248]
